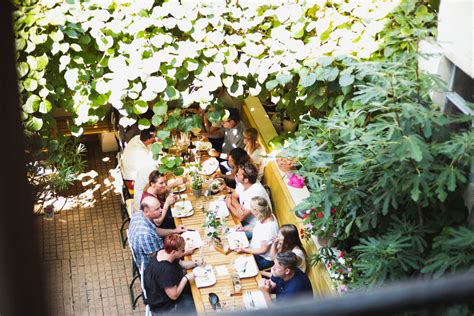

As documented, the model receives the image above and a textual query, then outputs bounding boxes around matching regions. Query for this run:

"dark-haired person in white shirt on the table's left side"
[122,126,156,187]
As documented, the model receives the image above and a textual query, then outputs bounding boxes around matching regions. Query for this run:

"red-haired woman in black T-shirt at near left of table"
[144,234,204,315]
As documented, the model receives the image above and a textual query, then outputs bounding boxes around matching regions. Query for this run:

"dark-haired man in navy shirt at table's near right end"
[258,250,313,305]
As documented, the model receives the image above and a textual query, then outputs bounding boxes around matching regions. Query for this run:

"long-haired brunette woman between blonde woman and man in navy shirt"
[262,224,307,277]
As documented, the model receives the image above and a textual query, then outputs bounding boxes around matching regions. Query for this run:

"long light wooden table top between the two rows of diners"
[174,168,261,315]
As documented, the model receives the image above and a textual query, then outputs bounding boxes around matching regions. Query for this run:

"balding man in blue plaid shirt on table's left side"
[128,196,188,267]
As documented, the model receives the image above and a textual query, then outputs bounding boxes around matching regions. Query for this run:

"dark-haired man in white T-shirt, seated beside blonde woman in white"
[226,162,272,238]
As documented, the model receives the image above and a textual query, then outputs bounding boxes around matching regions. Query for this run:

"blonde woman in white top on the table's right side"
[236,196,278,270]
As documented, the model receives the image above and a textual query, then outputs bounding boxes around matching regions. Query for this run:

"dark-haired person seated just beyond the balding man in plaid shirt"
[140,170,186,228]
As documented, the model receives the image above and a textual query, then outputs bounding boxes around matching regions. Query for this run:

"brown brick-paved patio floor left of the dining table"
[37,141,144,315]
